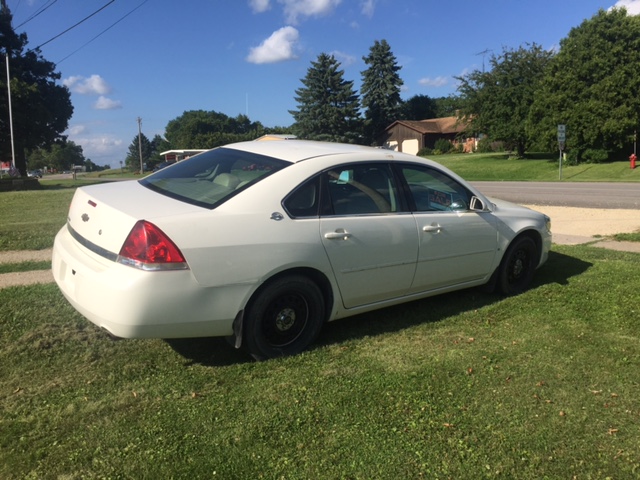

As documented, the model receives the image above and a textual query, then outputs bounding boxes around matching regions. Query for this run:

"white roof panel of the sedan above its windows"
[223,140,415,163]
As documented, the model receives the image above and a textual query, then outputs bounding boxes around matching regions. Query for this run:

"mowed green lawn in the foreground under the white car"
[0,247,640,479]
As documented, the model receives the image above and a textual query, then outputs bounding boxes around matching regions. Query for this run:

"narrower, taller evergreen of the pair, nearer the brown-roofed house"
[360,40,404,144]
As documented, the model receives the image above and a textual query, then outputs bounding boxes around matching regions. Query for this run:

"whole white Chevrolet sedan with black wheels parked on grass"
[53,140,551,359]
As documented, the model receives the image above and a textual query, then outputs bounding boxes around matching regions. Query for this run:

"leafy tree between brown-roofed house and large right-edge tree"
[458,43,553,157]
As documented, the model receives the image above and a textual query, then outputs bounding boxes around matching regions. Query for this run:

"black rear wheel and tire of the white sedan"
[243,275,325,360]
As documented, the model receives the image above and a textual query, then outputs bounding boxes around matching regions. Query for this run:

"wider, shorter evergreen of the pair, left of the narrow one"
[289,53,360,143]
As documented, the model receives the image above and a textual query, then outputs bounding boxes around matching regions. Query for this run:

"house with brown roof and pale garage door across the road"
[380,117,477,155]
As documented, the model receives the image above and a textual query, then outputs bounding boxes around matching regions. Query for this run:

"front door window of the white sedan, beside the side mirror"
[402,165,472,212]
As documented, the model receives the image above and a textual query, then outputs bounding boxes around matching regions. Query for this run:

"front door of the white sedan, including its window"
[400,165,498,293]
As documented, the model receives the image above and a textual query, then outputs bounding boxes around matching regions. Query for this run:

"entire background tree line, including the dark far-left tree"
[0,1,640,175]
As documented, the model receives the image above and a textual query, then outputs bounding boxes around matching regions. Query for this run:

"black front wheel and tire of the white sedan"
[498,237,538,295]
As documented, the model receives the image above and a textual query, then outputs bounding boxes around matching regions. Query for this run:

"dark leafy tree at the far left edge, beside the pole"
[0,0,73,176]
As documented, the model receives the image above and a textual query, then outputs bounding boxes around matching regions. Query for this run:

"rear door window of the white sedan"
[325,163,400,215]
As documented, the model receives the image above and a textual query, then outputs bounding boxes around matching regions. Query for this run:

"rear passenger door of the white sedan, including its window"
[320,163,418,308]
